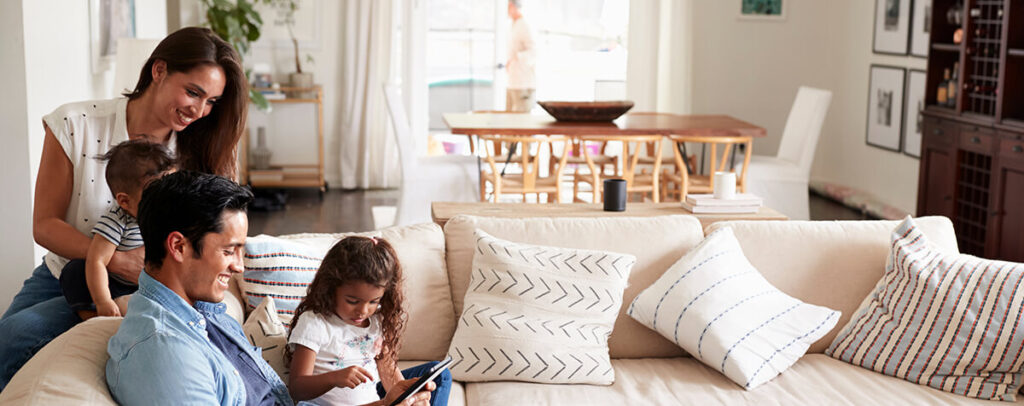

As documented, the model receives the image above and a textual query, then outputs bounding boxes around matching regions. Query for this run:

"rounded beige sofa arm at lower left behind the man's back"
[0,317,122,405]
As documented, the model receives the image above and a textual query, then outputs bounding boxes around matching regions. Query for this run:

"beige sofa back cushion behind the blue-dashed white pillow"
[708,217,957,354]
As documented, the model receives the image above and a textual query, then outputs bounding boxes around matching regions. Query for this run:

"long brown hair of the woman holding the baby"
[124,27,249,178]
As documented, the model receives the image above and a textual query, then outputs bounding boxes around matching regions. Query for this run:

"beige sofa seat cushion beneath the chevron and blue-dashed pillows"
[466,354,1024,406]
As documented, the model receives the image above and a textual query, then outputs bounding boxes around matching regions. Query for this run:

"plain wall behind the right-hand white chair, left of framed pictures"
[692,0,925,212]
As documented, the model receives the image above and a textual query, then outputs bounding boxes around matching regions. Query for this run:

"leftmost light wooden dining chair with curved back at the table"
[478,134,568,203]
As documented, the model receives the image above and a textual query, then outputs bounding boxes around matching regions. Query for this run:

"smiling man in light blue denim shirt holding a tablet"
[106,171,429,405]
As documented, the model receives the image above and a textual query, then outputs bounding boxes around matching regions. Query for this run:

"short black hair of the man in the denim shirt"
[138,170,253,269]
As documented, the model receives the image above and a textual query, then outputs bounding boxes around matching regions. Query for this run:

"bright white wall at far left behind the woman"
[0,0,167,310]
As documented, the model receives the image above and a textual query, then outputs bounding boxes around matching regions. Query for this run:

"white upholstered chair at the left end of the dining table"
[372,85,480,229]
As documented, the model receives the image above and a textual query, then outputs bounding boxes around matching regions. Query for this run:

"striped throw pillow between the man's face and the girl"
[239,236,330,327]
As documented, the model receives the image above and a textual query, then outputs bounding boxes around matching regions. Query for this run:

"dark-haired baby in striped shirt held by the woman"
[60,139,175,320]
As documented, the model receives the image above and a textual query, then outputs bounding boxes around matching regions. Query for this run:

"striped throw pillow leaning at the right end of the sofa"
[825,217,1024,401]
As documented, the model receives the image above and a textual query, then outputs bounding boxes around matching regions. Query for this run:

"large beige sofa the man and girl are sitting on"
[0,215,1024,405]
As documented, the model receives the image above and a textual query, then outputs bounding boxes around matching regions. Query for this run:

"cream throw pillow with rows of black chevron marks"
[449,230,636,384]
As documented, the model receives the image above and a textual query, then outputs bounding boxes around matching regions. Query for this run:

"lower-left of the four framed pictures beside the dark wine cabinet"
[865,65,906,152]
